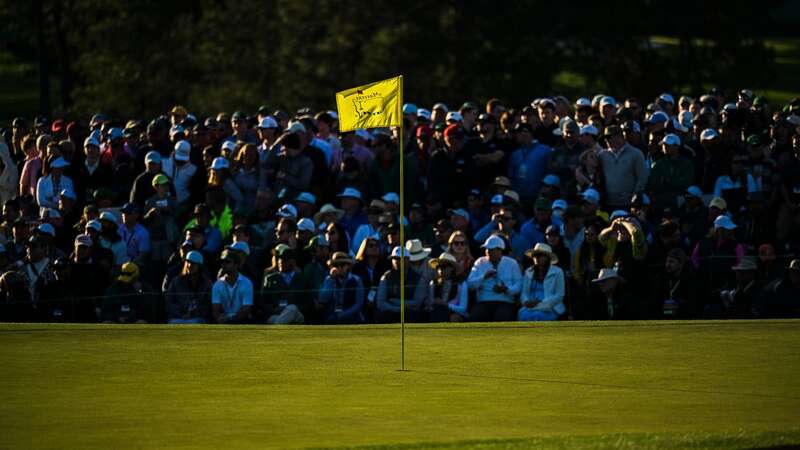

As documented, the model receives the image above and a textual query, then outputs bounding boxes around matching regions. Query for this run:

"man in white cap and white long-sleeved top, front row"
[467,236,522,322]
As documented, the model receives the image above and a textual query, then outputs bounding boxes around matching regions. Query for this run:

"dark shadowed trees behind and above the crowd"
[0,0,779,117]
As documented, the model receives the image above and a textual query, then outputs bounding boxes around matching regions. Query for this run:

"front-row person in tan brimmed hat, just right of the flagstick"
[428,253,469,322]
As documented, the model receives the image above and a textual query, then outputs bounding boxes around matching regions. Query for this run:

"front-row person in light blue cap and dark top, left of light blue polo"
[165,250,212,324]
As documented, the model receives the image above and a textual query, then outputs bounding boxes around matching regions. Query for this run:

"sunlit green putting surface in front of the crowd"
[0,321,800,449]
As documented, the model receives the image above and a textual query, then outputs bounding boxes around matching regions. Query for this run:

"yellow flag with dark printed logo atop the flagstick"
[336,75,403,131]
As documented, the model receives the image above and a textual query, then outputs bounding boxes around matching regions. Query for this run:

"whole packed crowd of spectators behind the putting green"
[0,89,800,324]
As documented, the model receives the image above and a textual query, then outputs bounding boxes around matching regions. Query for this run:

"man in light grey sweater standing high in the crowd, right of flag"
[599,125,648,209]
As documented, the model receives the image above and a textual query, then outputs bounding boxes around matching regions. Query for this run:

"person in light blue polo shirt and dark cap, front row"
[211,250,253,324]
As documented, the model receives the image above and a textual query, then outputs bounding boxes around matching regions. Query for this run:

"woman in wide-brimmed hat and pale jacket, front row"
[518,244,566,322]
